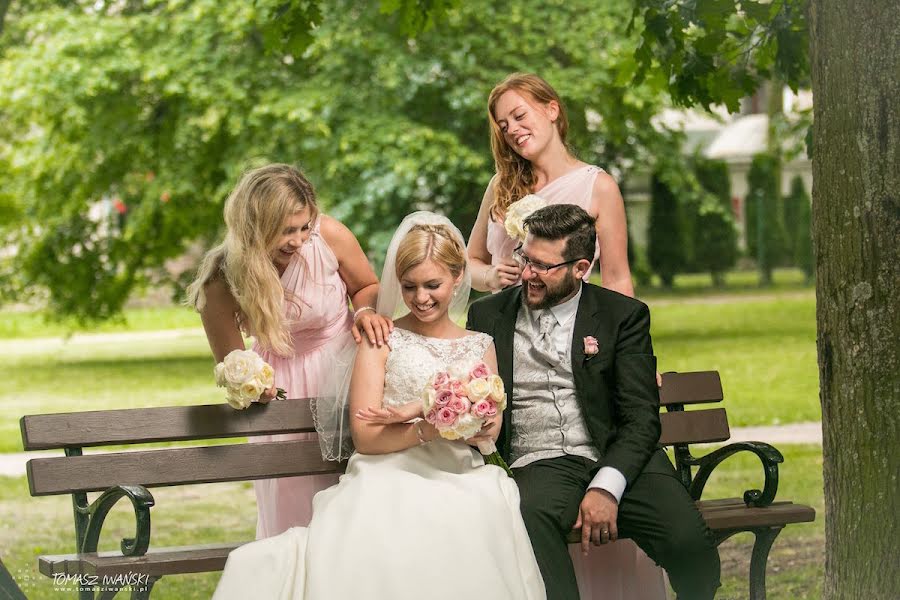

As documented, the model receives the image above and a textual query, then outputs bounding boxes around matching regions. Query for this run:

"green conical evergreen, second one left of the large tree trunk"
[745,153,785,285]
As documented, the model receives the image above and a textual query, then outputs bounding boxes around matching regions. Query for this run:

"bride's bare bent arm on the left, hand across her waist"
[350,338,437,454]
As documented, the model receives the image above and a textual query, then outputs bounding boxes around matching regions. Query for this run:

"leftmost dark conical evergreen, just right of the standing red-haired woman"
[647,175,685,288]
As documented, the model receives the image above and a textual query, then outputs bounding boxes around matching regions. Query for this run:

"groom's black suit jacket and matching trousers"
[467,284,719,600]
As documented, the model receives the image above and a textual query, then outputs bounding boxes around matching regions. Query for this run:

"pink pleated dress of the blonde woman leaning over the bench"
[250,218,353,539]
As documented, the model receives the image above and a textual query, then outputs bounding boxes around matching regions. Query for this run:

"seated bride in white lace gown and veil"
[214,212,545,600]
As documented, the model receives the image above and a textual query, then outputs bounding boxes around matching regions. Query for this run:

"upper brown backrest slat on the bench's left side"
[20,400,314,450]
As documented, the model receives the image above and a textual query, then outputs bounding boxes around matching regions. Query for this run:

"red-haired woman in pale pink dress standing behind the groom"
[468,73,666,600]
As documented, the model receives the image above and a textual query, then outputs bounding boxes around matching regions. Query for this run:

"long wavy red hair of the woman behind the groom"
[488,73,569,221]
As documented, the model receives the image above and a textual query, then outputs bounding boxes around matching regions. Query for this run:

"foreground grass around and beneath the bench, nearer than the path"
[0,446,824,600]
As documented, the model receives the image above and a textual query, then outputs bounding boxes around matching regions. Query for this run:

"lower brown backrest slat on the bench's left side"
[26,438,343,496]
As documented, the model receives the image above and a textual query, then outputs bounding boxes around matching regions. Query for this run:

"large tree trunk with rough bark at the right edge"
[810,0,900,600]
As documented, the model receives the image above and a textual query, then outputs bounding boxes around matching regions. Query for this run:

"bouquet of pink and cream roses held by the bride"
[422,361,512,477]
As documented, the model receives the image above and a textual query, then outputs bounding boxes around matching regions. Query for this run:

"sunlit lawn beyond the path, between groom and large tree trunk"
[649,295,821,426]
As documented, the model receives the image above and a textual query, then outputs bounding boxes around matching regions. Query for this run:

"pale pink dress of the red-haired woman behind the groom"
[487,165,666,600]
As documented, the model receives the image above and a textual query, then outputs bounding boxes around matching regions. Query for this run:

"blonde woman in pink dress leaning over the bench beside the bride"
[188,164,393,539]
